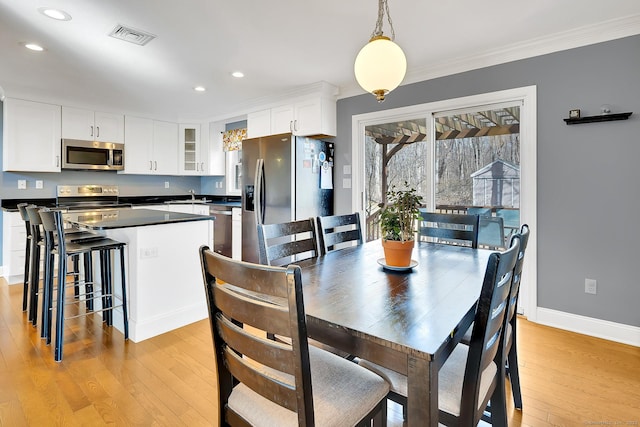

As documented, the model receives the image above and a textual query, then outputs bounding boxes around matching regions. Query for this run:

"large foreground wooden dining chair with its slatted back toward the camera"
[200,246,389,426]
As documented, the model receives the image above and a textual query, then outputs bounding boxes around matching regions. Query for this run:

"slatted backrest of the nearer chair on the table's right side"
[460,240,520,425]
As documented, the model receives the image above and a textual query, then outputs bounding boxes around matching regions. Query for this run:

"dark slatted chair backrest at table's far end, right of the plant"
[418,210,479,248]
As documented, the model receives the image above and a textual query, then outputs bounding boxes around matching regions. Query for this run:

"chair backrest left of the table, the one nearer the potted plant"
[318,212,362,254]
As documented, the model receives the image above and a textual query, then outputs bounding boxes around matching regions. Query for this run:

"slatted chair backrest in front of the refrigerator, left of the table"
[258,218,319,265]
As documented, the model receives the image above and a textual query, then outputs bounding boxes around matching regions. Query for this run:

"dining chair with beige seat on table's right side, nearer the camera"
[359,239,520,426]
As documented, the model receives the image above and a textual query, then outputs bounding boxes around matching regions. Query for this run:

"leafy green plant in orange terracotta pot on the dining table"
[380,182,422,267]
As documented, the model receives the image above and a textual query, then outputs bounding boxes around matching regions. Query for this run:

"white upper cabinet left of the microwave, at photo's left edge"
[2,98,61,172]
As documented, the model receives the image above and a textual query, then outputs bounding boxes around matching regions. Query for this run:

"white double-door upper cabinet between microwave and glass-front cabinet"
[124,116,178,175]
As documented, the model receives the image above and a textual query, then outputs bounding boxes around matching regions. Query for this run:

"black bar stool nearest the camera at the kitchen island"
[39,208,129,362]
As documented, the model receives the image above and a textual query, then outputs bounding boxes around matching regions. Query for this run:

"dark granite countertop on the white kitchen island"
[64,208,214,230]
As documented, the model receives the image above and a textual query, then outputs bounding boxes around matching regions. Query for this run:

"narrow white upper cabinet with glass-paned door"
[178,124,209,175]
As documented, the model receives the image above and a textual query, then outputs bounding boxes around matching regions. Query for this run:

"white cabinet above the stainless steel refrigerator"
[247,97,336,138]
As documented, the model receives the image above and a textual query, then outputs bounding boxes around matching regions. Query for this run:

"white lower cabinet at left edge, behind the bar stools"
[2,211,27,284]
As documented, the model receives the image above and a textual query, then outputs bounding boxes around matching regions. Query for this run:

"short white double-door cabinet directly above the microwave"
[62,106,124,143]
